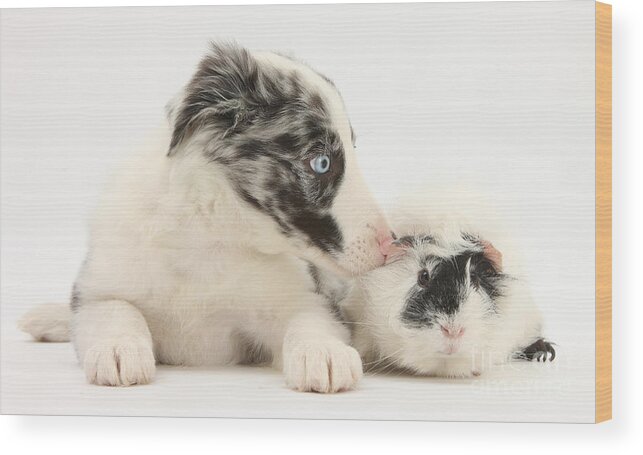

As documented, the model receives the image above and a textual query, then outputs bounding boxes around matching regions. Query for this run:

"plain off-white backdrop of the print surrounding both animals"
[0,1,594,421]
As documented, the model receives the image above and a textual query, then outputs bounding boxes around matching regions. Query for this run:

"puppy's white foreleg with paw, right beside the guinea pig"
[281,309,362,393]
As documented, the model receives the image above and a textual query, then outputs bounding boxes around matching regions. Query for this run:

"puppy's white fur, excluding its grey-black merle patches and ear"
[24,49,388,392]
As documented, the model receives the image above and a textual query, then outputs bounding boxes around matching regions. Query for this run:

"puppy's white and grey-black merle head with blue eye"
[168,44,391,275]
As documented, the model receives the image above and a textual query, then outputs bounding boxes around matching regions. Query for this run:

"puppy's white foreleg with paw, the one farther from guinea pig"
[73,300,156,386]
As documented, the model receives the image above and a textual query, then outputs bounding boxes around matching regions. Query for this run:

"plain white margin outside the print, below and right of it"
[2,2,642,453]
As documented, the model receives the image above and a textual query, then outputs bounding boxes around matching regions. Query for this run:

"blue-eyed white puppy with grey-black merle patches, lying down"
[23,44,392,392]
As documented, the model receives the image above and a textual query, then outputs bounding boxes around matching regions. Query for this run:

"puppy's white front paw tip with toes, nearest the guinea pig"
[284,340,362,393]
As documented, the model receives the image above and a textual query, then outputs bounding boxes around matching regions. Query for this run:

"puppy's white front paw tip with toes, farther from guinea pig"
[84,338,156,386]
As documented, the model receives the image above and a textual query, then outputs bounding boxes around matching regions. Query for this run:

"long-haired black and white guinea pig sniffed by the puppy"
[341,225,556,377]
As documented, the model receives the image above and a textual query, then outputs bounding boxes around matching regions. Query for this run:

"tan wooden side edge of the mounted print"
[596,2,612,422]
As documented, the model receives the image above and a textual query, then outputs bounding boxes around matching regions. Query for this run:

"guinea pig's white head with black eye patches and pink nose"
[363,231,507,377]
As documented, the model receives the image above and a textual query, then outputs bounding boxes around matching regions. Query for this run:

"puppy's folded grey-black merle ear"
[168,43,261,156]
